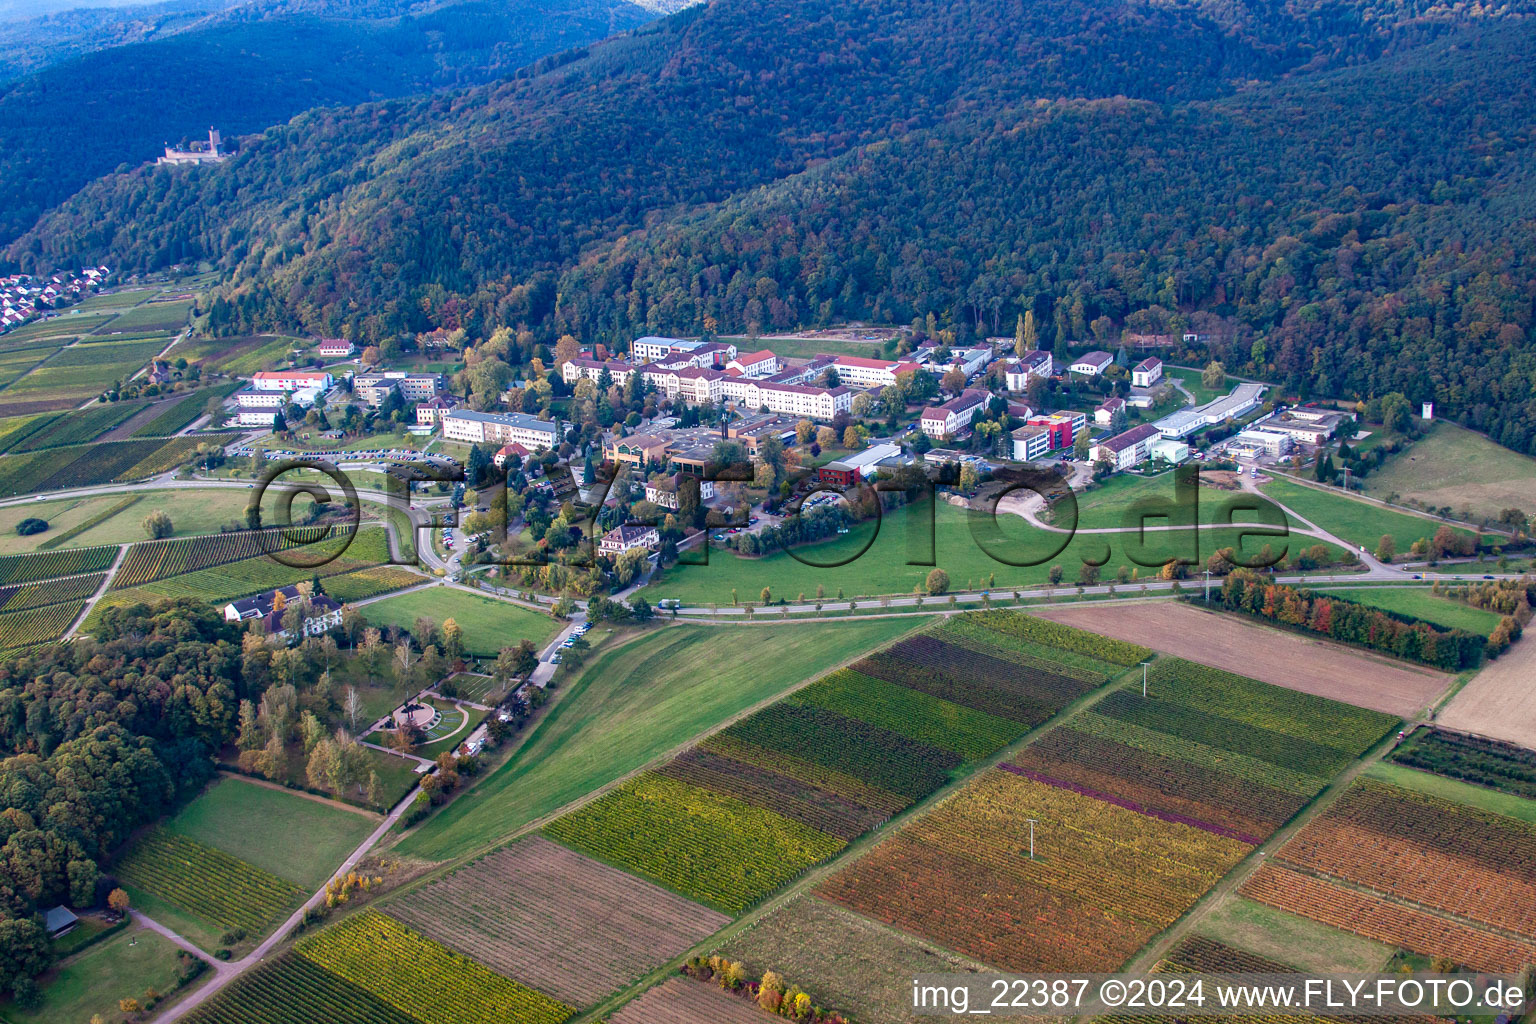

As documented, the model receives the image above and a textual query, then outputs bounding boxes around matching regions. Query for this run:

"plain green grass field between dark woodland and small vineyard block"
[167,778,376,889]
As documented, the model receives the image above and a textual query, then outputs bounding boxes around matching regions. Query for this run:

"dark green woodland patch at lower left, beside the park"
[0,600,239,996]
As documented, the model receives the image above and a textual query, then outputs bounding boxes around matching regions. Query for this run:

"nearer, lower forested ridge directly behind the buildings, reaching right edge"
[559,26,1536,453]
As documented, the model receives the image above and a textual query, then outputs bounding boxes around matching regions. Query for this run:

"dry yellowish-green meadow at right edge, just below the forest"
[1366,421,1536,517]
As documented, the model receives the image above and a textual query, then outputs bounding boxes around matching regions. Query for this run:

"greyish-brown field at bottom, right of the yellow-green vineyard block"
[380,837,730,1006]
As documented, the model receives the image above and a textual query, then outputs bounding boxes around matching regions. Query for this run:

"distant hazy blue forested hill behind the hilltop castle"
[0,0,654,241]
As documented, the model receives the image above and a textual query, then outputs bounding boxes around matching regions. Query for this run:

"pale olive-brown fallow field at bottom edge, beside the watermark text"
[720,895,988,1024]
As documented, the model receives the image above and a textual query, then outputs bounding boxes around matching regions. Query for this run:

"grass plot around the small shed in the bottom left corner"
[0,927,195,1024]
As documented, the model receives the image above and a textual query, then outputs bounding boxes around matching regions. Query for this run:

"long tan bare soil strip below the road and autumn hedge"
[1031,600,1449,715]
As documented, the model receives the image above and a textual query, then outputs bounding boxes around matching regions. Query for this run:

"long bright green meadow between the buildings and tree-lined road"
[645,502,1339,605]
